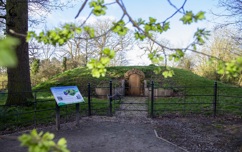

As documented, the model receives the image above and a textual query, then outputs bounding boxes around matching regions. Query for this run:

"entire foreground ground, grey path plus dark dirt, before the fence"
[0,117,242,152]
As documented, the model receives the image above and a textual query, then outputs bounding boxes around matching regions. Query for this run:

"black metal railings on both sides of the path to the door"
[0,81,242,133]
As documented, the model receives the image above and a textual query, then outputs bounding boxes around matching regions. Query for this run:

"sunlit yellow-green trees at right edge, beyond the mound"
[195,29,242,84]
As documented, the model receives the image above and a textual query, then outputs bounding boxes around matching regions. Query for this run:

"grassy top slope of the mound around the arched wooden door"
[34,66,214,90]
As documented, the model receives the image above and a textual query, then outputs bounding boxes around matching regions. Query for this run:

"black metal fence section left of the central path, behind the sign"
[0,81,120,134]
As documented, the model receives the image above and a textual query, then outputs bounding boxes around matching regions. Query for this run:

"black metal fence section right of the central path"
[149,82,242,117]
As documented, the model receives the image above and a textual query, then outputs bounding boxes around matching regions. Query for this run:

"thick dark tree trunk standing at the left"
[6,0,33,105]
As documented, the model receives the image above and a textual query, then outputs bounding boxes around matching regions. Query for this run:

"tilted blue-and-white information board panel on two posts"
[50,86,84,106]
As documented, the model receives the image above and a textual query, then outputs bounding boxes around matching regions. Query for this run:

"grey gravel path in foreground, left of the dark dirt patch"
[0,117,183,152]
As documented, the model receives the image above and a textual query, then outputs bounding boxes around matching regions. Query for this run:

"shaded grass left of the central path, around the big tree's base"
[0,92,114,130]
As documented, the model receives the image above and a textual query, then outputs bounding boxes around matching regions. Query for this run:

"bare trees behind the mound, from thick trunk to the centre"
[30,19,135,84]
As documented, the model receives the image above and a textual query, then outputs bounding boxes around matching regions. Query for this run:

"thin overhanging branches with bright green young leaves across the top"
[22,0,238,77]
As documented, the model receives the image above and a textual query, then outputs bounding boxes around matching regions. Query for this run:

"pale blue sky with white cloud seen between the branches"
[40,0,225,65]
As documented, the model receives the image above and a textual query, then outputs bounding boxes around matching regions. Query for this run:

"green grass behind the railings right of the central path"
[150,85,242,117]
